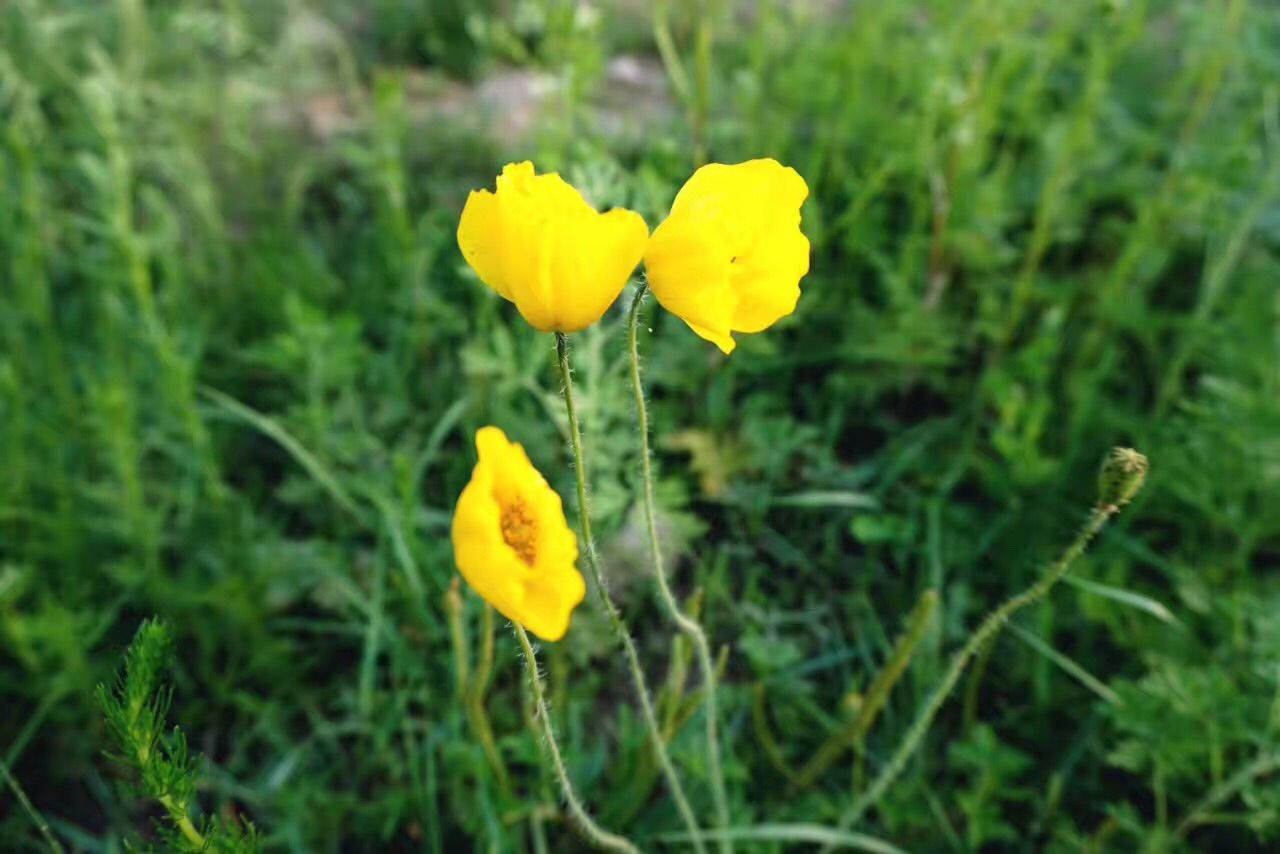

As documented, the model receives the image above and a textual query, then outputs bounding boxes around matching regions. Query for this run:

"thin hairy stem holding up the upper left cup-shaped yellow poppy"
[556,332,707,854]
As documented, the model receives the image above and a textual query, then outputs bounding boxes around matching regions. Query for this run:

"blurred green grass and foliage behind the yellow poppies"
[0,0,1280,851]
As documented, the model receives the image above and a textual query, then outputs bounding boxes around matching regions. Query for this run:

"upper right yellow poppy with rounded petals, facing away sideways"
[644,159,809,353]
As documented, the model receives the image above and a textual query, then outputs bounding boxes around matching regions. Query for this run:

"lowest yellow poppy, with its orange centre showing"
[453,426,586,640]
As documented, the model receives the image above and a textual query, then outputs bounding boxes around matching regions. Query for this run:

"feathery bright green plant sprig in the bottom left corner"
[97,620,260,851]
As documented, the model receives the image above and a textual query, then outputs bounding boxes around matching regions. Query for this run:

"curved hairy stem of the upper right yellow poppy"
[627,289,733,854]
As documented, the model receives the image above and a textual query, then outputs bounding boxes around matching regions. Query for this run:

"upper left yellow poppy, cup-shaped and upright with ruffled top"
[458,161,649,332]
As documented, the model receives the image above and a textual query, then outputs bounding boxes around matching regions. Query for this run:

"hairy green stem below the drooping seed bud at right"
[840,503,1120,831]
